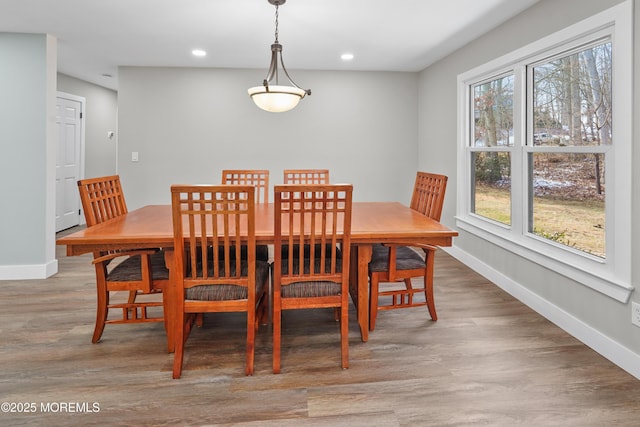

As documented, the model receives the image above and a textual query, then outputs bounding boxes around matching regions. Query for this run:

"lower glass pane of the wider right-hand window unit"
[529,153,605,258]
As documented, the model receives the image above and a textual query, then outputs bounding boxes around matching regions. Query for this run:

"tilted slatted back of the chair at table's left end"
[78,175,127,227]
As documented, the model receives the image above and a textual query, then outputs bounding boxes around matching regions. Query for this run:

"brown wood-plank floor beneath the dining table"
[0,232,640,427]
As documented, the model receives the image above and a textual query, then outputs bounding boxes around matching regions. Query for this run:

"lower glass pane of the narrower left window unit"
[471,152,511,225]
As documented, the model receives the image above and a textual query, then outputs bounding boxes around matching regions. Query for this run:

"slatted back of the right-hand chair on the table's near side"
[273,184,353,285]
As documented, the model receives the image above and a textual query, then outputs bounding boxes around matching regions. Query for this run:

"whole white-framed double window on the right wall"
[457,2,633,302]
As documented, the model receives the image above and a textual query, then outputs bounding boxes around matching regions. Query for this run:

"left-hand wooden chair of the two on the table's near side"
[171,185,269,378]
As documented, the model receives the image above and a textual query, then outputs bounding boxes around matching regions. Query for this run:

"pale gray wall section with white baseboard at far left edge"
[0,33,58,279]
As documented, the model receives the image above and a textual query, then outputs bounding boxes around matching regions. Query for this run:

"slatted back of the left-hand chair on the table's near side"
[171,185,256,290]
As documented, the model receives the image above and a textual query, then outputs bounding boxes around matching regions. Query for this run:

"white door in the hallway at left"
[56,94,84,232]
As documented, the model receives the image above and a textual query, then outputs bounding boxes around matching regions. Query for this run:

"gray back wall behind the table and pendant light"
[118,67,418,208]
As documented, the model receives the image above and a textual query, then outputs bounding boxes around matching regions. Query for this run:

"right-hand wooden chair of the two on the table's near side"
[272,184,353,373]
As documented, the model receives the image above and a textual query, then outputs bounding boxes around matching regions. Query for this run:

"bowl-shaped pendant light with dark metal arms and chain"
[248,0,311,113]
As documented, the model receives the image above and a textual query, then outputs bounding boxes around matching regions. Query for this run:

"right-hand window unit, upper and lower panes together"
[526,38,613,259]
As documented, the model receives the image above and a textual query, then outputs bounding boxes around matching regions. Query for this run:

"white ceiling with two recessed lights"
[0,0,538,90]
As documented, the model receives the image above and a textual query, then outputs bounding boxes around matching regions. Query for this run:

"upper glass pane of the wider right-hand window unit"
[533,43,611,146]
